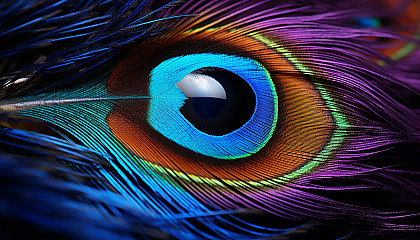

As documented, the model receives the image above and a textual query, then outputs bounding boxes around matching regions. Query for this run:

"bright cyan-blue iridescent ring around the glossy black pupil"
[148,53,278,159]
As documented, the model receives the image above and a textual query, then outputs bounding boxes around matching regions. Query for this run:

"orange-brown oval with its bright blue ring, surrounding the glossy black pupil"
[107,29,342,186]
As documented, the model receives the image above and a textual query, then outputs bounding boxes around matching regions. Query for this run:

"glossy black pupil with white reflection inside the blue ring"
[177,68,256,136]
